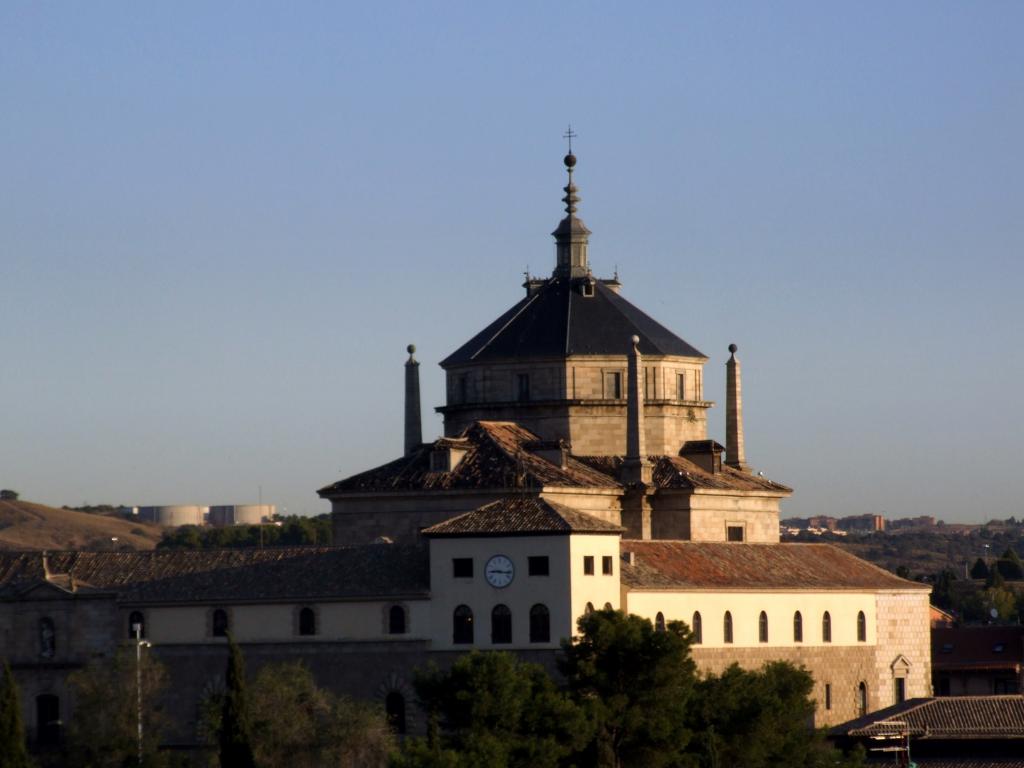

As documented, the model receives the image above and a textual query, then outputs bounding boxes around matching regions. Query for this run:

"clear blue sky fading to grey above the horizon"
[0,1,1024,522]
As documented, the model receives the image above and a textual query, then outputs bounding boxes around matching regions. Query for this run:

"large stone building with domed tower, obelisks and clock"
[0,148,931,743]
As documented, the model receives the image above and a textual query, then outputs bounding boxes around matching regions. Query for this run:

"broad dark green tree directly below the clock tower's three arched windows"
[397,651,590,768]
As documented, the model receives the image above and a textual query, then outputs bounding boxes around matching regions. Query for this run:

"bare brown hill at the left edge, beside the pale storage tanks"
[0,501,164,550]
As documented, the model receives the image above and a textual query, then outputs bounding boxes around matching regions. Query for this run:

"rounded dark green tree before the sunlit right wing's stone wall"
[689,662,842,768]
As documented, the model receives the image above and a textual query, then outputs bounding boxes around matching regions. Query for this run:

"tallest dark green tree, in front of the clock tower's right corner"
[559,609,696,768]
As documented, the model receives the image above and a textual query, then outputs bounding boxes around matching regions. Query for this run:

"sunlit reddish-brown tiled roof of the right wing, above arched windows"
[621,540,931,591]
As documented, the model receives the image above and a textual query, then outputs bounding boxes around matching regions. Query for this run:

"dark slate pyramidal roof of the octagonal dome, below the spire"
[440,278,706,368]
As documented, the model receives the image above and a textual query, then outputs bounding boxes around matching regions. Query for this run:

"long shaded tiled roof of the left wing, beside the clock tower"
[0,544,429,602]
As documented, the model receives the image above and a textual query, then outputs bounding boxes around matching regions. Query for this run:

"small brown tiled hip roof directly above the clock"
[423,496,625,537]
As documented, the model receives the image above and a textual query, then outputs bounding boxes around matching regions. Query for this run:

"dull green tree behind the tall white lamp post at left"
[68,645,167,768]
